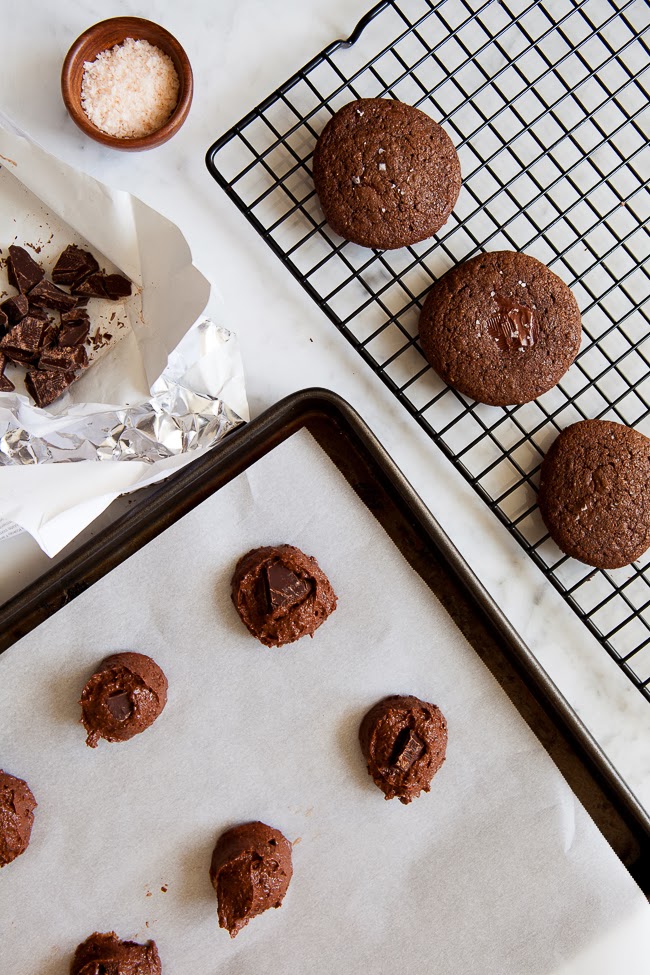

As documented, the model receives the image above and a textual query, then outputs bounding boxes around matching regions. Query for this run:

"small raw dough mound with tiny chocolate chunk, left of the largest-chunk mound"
[79,652,167,748]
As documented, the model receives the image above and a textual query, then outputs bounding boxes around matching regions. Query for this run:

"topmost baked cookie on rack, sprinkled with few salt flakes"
[313,98,461,250]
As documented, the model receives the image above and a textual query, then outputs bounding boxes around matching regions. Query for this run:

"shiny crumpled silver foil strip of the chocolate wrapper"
[0,322,244,467]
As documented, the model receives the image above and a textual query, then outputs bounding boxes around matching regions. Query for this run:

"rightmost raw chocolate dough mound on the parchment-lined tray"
[359,694,447,805]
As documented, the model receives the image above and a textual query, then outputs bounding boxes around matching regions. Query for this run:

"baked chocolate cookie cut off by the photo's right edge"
[537,420,650,569]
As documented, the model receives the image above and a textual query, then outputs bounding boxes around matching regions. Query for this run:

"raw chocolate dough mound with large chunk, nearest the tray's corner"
[232,545,336,647]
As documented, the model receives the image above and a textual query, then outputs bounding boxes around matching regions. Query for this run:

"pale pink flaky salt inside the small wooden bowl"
[81,37,180,139]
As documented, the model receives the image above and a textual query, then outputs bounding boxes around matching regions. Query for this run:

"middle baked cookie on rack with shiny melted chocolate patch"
[420,251,582,406]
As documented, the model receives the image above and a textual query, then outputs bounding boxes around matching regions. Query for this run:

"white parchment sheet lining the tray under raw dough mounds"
[0,433,650,975]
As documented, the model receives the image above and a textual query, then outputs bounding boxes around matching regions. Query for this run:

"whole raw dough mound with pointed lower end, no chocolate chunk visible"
[210,822,293,938]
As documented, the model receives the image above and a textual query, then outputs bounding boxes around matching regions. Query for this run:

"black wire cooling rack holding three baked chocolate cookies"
[207,0,650,699]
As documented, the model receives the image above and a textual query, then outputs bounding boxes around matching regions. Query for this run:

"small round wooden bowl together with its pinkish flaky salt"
[61,17,194,152]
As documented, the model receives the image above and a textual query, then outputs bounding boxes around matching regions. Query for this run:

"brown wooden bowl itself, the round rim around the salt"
[61,17,194,152]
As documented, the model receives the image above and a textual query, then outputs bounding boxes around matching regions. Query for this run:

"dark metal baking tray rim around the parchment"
[0,389,650,892]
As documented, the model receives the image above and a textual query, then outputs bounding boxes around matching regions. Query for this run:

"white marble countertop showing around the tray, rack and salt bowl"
[0,0,650,824]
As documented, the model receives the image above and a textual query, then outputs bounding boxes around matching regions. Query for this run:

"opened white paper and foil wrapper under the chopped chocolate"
[0,123,248,555]
